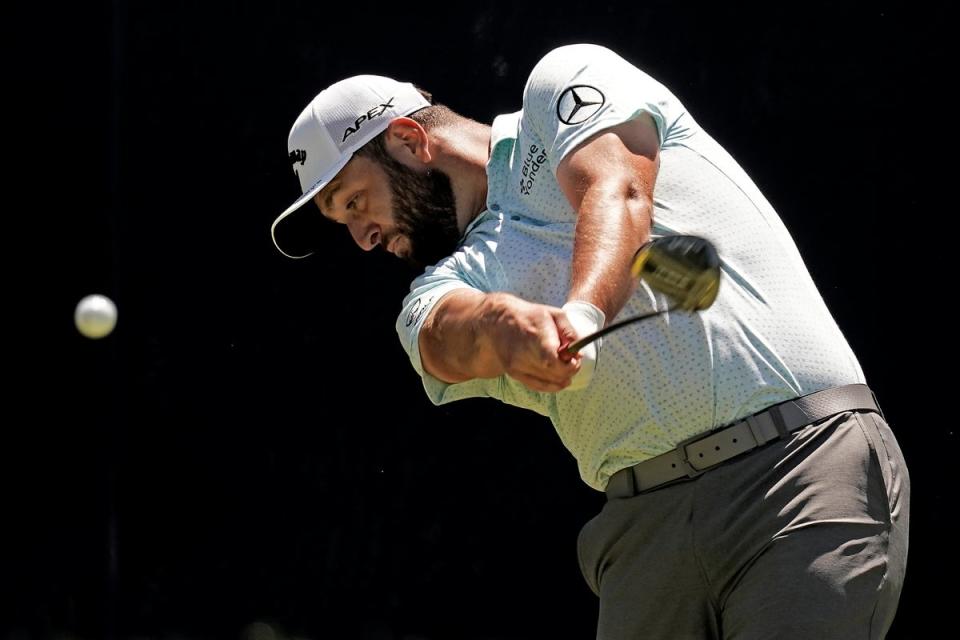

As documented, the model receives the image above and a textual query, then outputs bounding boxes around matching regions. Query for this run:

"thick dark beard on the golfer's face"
[379,154,460,269]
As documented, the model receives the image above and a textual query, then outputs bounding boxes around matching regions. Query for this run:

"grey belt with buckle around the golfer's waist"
[606,384,882,499]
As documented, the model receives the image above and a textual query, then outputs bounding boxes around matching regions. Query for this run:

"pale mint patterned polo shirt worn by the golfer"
[396,44,865,490]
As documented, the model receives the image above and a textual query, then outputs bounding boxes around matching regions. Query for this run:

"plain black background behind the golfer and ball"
[0,0,957,640]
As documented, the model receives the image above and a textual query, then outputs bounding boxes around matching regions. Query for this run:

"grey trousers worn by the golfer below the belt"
[577,412,910,640]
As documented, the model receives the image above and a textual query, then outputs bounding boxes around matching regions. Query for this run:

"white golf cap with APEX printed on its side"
[270,76,430,258]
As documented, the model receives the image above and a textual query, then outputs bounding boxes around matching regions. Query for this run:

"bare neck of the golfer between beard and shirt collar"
[430,118,490,233]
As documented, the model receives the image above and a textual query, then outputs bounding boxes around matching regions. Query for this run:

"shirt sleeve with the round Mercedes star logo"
[521,44,671,172]
